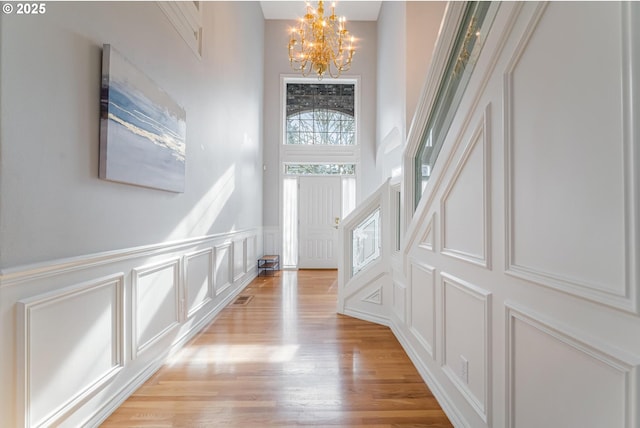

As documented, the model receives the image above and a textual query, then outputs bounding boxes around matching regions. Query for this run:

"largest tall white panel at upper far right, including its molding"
[504,2,640,312]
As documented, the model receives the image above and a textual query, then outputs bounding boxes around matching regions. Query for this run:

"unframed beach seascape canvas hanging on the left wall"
[99,44,187,192]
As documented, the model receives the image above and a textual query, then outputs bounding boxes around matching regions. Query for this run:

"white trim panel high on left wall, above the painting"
[157,1,203,58]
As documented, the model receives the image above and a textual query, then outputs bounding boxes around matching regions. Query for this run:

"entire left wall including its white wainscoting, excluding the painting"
[0,2,264,426]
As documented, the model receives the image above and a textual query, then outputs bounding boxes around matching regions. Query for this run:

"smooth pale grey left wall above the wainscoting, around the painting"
[0,2,263,268]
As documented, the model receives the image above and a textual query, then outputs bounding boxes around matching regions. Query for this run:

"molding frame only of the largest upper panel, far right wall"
[503,2,640,314]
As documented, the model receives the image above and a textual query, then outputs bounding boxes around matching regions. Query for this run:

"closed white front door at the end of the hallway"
[298,177,342,269]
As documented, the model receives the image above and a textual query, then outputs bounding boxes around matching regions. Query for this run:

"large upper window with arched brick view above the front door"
[285,83,356,146]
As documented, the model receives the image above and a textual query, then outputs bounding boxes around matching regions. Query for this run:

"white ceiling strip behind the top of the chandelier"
[260,0,382,21]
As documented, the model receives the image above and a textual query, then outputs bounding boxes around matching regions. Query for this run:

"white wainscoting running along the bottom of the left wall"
[0,228,262,428]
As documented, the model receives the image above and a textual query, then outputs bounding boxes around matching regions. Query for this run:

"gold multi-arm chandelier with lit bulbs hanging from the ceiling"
[289,1,356,79]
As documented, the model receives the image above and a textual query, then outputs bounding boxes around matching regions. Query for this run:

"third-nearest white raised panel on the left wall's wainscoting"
[183,247,216,318]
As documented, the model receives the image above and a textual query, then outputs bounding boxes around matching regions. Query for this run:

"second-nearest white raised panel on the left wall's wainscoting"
[131,258,183,360]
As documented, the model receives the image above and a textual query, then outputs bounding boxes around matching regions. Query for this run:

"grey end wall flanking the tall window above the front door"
[264,18,377,227]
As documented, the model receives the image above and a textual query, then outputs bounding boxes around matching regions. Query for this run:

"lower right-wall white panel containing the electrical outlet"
[441,273,491,426]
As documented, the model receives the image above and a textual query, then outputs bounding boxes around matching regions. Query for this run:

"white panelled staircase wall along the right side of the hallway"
[339,2,640,428]
